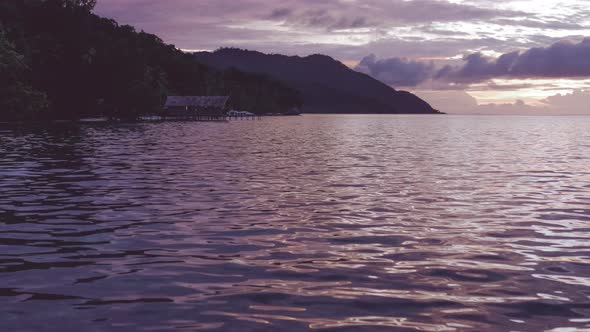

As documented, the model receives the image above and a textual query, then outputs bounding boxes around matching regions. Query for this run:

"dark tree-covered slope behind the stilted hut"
[0,0,302,121]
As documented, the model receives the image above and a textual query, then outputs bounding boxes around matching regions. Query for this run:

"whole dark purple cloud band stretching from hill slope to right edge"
[356,38,590,86]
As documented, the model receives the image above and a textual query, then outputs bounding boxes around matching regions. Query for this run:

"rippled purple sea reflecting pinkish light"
[0,116,590,332]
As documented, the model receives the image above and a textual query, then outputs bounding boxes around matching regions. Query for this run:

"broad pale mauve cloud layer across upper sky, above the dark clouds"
[95,0,564,60]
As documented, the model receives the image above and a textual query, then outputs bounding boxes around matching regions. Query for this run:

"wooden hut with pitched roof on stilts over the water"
[162,96,229,120]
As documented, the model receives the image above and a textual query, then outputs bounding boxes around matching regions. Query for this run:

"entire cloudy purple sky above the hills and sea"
[95,0,590,114]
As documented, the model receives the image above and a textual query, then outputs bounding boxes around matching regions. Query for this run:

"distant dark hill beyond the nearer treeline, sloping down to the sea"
[194,48,440,114]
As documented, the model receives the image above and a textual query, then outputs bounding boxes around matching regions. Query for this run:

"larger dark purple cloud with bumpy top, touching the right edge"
[435,38,590,83]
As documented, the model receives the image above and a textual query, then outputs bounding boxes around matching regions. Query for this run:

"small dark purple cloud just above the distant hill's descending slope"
[355,54,435,87]
